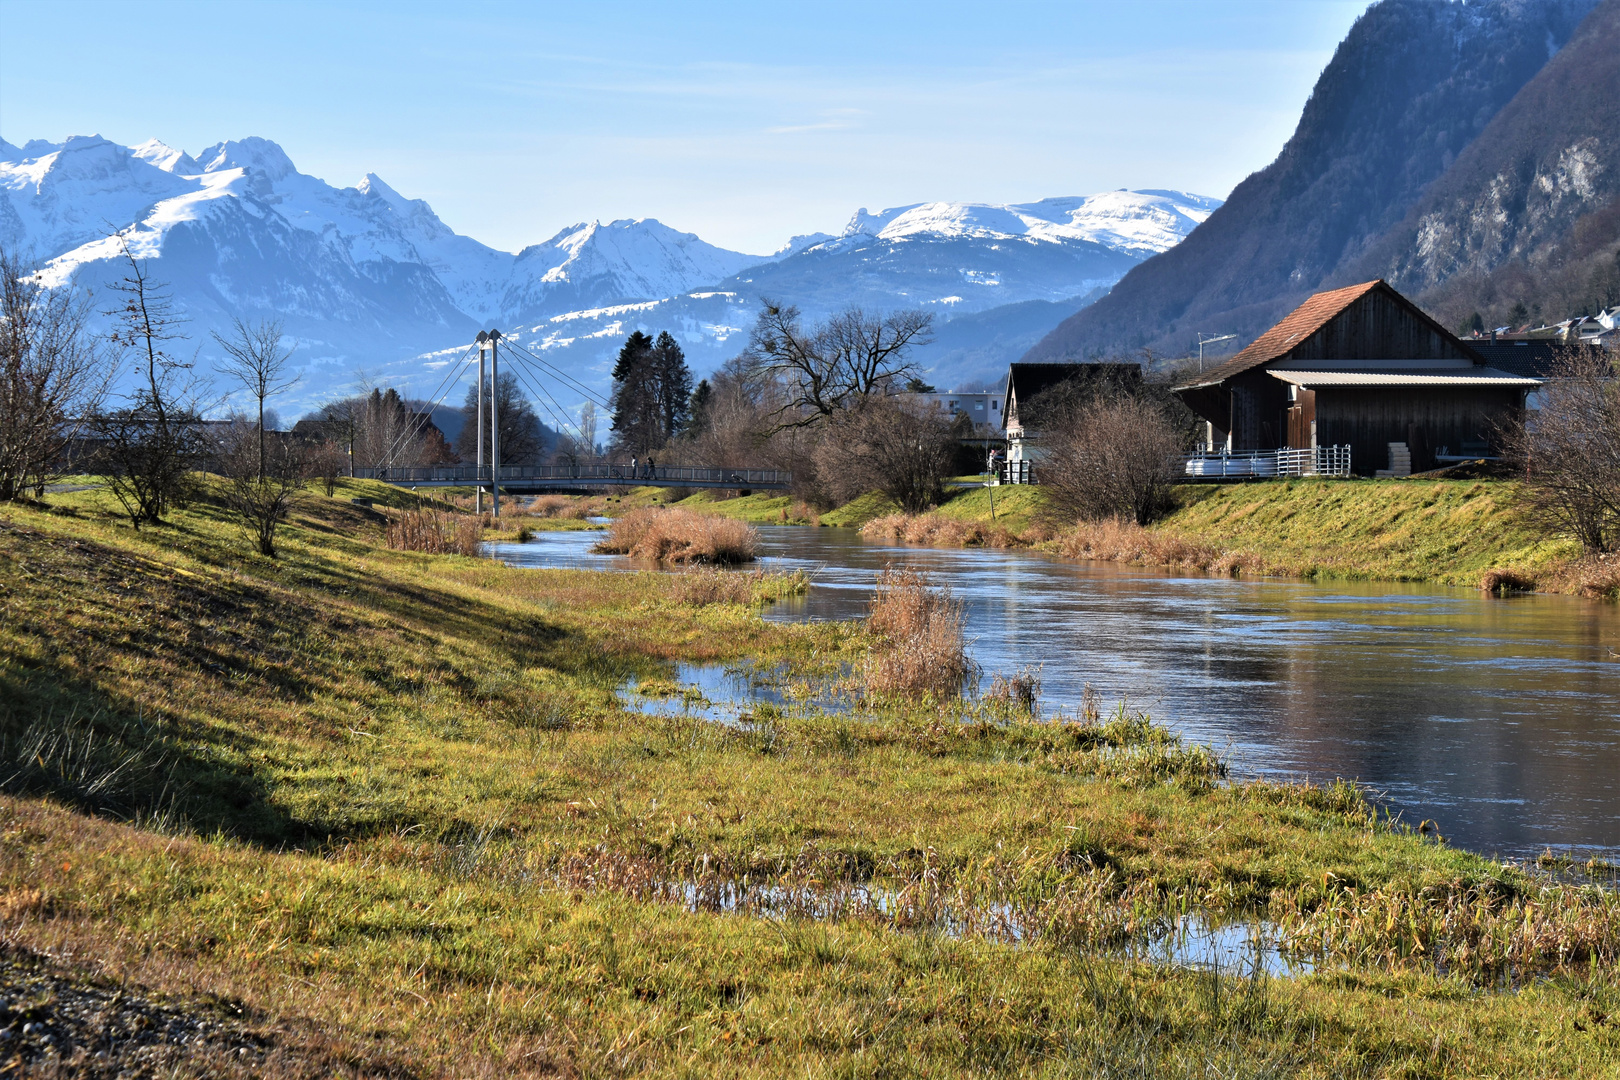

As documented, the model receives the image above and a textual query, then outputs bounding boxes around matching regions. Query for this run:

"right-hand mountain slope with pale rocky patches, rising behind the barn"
[1345,0,1620,325]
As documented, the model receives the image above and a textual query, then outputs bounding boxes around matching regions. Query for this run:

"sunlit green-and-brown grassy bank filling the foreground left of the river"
[0,483,1620,1077]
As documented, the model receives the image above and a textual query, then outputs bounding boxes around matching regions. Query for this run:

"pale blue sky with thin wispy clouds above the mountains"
[0,0,1367,254]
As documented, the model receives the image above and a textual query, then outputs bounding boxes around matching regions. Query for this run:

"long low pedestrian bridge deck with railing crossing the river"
[355,465,794,495]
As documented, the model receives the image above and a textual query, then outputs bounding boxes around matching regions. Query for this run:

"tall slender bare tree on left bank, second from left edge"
[91,244,206,528]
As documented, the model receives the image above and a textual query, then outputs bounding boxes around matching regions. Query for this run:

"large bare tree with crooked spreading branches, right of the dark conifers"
[744,300,933,431]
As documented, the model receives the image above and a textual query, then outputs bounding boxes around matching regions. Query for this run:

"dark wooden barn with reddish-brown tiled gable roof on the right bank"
[1175,280,1541,476]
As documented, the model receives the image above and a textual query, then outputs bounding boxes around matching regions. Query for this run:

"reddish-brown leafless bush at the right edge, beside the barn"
[1499,347,1620,552]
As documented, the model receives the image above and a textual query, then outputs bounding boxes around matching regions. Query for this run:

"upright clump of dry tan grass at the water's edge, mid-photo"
[863,567,974,699]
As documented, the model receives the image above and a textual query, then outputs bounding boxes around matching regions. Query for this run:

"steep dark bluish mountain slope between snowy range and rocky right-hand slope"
[1025,0,1594,361]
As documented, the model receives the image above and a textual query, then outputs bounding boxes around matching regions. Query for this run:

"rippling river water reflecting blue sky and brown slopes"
[491,526,1620,858]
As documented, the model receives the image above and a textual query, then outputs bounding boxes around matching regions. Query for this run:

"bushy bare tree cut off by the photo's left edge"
[0,248,112,502]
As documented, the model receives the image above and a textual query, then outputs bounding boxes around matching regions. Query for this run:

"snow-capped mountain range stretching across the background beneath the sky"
[0,136,1218,413]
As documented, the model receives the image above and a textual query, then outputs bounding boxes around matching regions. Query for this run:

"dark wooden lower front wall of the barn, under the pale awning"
[1315,387,1520,474]
